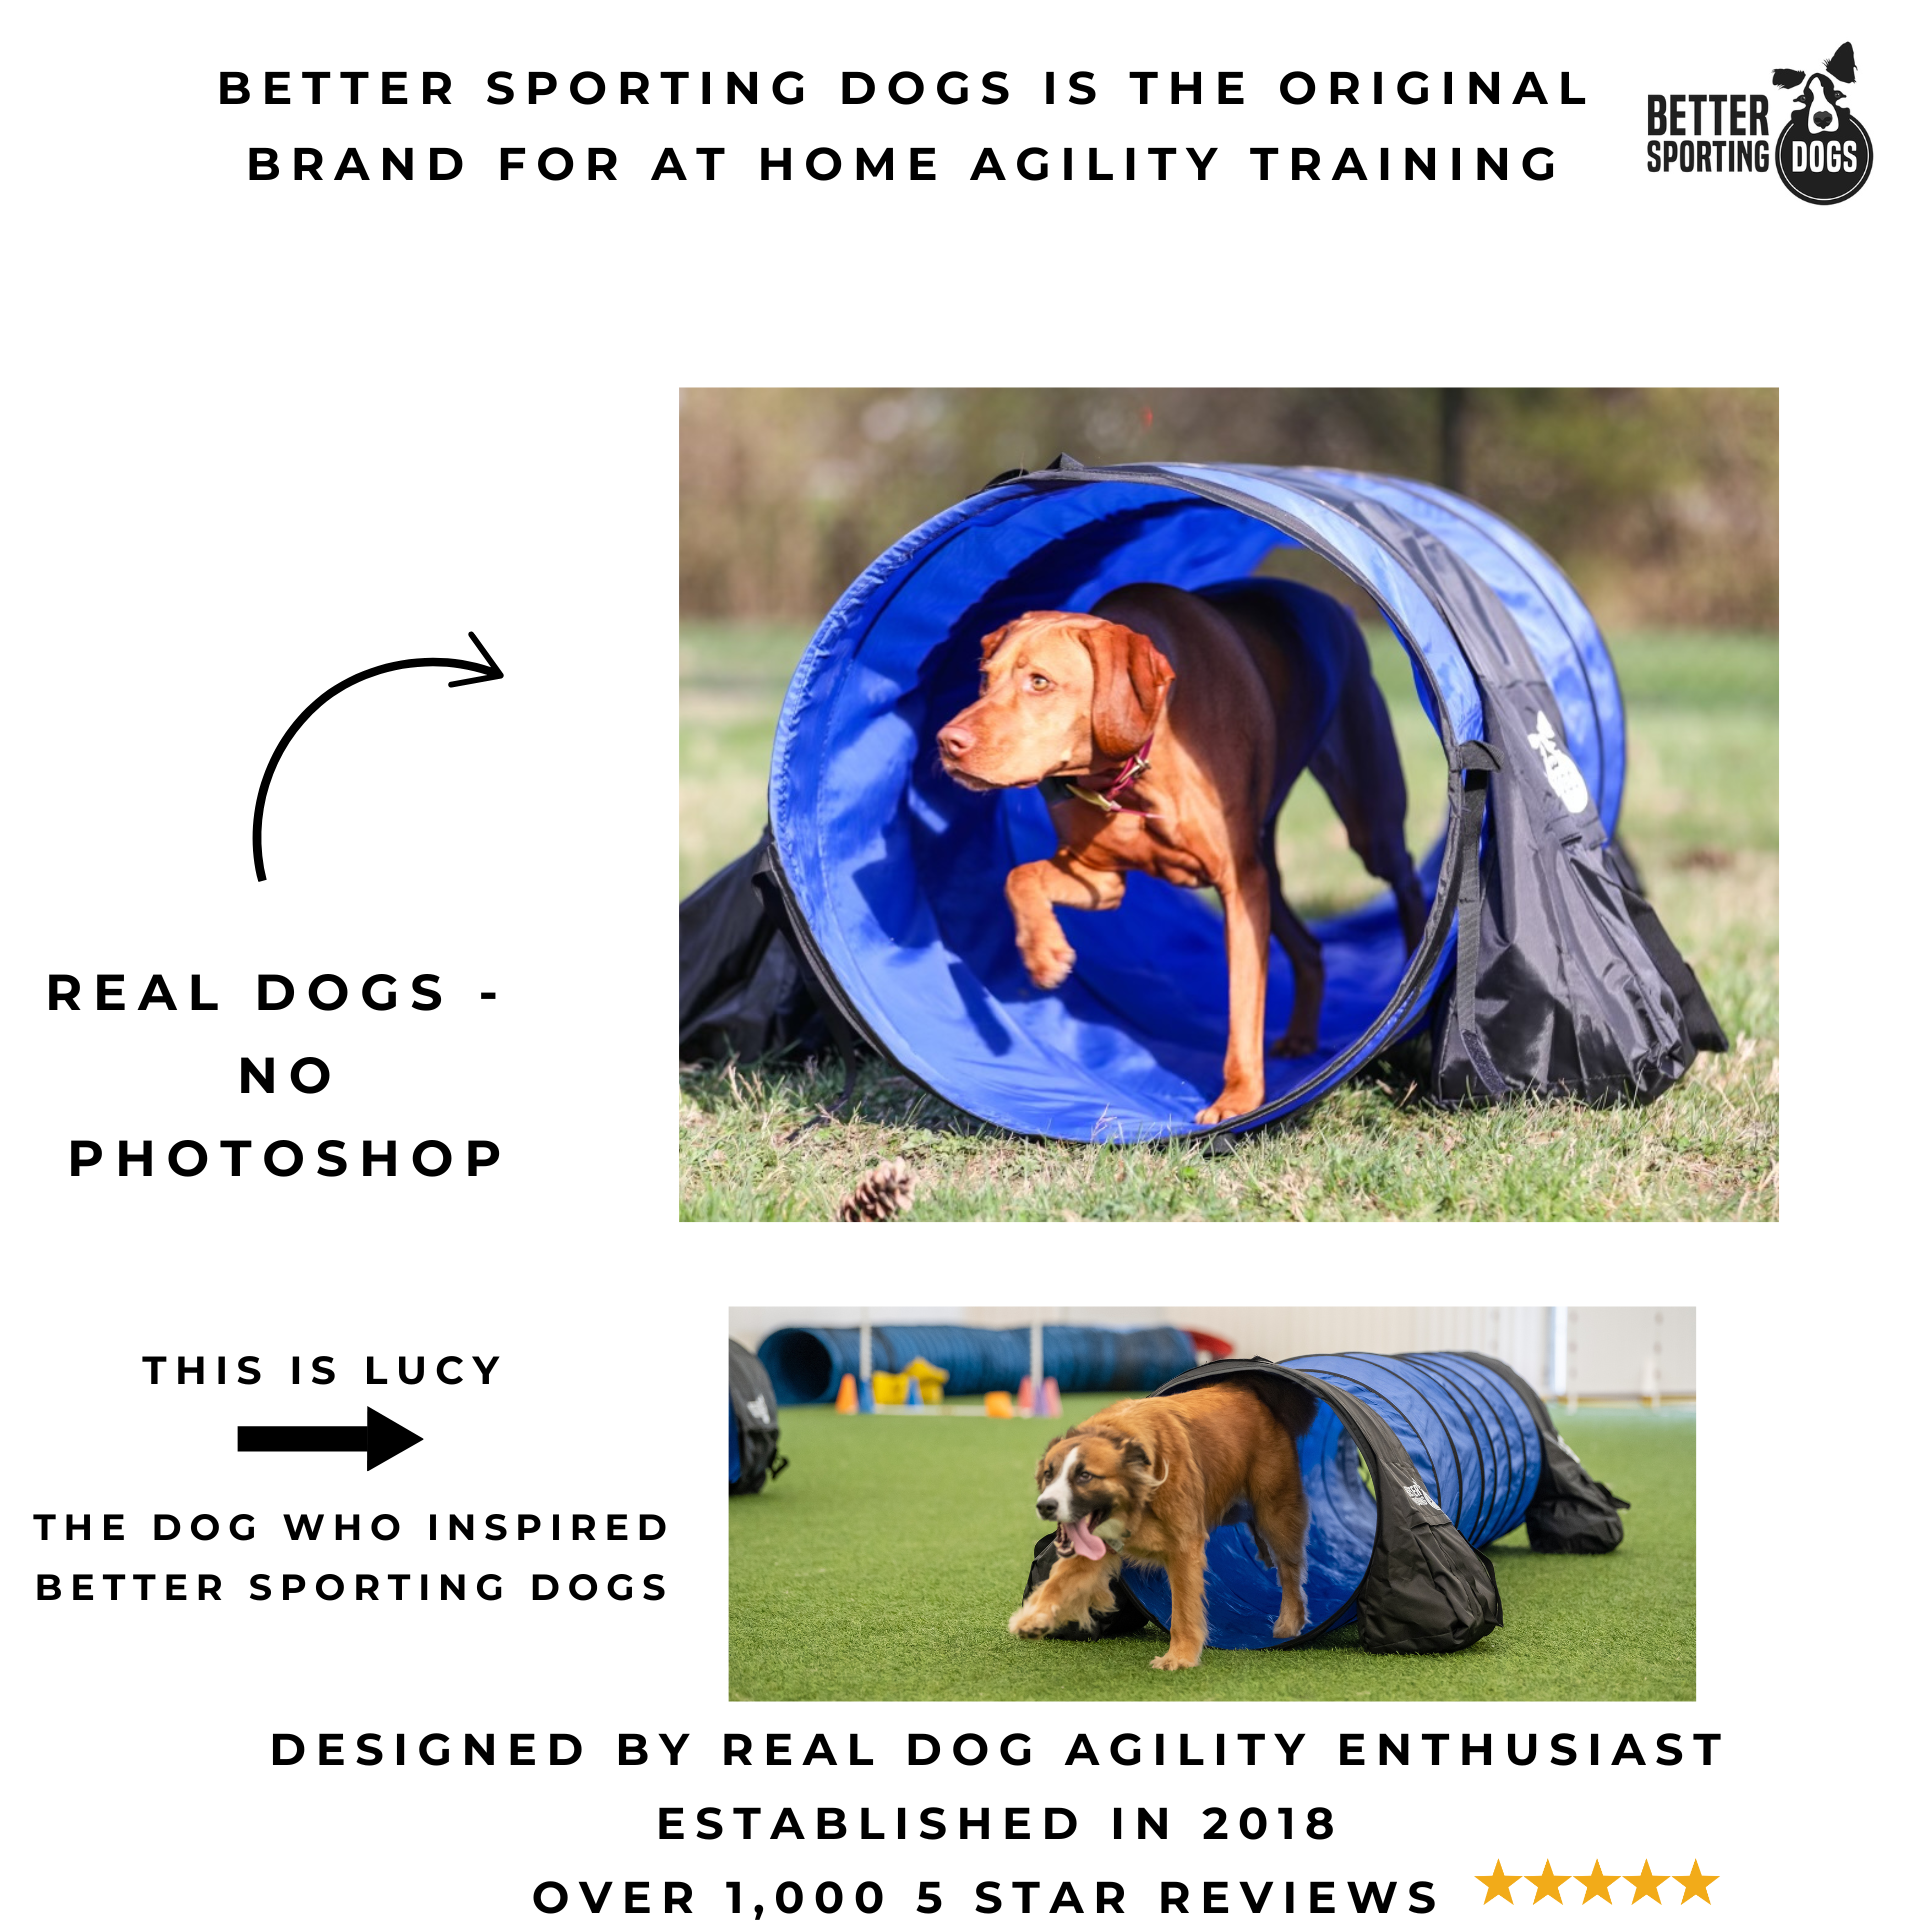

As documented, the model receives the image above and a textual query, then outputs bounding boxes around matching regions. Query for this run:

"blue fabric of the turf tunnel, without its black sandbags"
[1125,1354,1544,1647]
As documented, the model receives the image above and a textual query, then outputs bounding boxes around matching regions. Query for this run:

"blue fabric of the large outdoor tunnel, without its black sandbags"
[768,465,1626,1140]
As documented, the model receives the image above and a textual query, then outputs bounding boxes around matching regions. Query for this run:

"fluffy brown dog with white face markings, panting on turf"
[1006,1377,1315,1670]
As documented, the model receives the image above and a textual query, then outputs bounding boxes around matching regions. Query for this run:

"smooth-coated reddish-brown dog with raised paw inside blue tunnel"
[939,582,1427,1125]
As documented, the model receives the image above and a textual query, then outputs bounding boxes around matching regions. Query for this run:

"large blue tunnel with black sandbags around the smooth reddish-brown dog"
[737,463,1726,1140]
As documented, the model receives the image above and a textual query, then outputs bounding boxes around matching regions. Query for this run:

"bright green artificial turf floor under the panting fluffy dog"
[730,1396,1693,1699]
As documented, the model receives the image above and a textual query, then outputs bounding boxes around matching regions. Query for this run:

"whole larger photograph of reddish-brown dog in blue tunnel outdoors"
[680,388,1780,1225]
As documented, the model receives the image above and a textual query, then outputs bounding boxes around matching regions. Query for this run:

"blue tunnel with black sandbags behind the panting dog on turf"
[1027,1354,1626,1653]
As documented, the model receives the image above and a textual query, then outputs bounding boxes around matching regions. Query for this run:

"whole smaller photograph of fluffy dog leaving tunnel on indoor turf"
[728,1308,1695,1701]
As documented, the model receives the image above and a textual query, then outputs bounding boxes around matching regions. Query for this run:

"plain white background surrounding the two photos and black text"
[0,0,1914,1920]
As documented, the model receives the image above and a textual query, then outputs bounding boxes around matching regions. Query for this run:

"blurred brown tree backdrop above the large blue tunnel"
[680,388,1780,634]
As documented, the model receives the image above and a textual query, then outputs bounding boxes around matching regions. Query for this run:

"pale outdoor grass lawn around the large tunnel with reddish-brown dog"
[680,626,1780,1219]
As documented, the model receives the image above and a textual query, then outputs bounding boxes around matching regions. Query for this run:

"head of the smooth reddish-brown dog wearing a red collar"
[939,612,1173,791]
